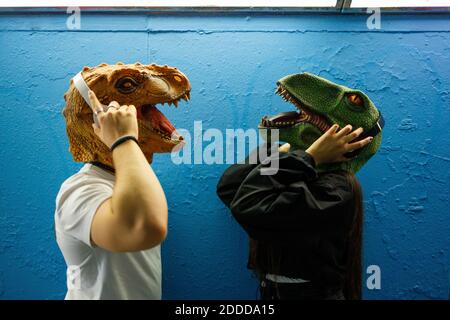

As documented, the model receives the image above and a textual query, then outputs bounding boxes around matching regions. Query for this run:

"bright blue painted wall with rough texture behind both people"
[0,13,450,299]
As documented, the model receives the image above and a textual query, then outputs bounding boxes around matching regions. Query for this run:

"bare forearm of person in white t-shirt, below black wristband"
[112,140,167,233]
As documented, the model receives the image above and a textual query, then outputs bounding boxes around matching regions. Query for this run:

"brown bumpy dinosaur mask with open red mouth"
[63,62,191,166]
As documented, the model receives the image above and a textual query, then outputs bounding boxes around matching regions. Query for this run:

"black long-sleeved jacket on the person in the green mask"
[217,151,354,287]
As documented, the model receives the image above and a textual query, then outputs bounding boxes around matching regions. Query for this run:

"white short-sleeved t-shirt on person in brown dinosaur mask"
[55,164,161,300]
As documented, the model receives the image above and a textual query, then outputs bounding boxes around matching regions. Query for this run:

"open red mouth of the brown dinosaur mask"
[137,92,190,144]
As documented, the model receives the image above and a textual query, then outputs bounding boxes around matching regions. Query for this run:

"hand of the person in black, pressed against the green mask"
[306,124,373,165]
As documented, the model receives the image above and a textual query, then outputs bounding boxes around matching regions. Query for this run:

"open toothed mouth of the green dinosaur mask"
[259,84,331,132]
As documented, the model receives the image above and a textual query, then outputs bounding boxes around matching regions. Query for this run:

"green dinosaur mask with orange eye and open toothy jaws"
[259,73,384,173]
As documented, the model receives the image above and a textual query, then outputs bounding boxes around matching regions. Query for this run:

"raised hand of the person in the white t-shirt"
[89,91,138,148]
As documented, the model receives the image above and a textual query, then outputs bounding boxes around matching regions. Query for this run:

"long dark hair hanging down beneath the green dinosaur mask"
[249,171,364,300]
